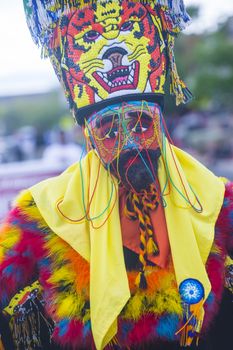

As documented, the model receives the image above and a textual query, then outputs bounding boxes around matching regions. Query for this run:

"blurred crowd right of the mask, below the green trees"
[168,111,233,179]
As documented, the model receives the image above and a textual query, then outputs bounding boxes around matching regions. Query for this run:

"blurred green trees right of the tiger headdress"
[172,13,233,112]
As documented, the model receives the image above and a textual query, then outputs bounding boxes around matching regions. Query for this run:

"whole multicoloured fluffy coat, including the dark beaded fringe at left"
[0,183,233,350]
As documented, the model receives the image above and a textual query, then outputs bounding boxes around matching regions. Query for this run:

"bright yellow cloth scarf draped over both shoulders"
[30,142,224,350]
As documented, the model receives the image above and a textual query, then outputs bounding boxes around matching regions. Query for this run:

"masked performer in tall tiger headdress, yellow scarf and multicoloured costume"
[0,0,233,350]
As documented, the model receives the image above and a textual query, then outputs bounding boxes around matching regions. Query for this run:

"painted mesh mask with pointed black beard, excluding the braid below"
[86,101,162,193]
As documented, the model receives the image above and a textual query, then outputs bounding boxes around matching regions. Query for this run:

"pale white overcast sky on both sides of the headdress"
[0,0,233,96]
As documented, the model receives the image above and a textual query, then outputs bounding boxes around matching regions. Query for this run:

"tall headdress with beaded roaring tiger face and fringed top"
[24,0,191,124]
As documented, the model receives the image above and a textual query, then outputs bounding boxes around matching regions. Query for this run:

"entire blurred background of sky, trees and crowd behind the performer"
[0,0,233,217]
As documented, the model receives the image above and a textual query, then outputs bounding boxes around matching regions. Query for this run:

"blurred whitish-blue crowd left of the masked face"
[0,126,83,168]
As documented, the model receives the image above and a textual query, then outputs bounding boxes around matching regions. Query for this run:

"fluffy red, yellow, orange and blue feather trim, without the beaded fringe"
[0,183,233,349]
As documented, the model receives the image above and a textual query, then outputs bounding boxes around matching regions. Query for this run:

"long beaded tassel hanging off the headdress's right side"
[168,34,193,105]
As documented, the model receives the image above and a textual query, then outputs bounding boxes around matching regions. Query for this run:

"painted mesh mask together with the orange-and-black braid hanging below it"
[86,101,166,289]
